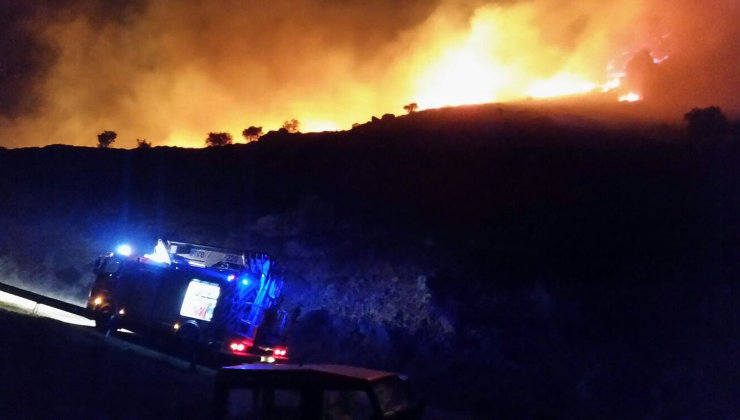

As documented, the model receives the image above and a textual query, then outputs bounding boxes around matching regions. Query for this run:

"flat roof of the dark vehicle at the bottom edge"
[221,363,396,383]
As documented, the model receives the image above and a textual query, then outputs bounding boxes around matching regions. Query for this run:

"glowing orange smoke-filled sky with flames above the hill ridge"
[0,0,740,147]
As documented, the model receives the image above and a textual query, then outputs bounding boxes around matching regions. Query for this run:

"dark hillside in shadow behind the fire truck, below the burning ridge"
[0,104,740,418]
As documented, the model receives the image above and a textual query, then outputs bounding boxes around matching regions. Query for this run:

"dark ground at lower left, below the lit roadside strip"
[0,307,214,420]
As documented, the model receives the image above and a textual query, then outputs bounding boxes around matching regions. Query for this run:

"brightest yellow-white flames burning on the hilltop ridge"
[414,6,652,109]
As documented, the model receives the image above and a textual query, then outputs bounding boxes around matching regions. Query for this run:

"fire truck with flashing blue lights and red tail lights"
[87,240,288,363]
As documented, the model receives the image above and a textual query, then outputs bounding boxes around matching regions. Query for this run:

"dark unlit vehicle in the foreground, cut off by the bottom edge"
[214,364,423,420]
